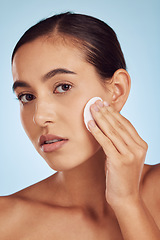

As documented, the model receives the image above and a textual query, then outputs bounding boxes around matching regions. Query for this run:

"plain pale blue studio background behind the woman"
[0,0,160,195]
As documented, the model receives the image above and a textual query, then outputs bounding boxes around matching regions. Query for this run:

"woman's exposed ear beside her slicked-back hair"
[110,69,131,112]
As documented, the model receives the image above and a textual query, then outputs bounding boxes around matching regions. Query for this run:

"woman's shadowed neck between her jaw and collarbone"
[58,149,108,217]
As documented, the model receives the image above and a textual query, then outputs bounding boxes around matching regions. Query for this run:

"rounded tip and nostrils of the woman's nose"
[33,101,55,127]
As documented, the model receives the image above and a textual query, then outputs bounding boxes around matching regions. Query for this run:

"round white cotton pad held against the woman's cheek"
[83,97,102,131]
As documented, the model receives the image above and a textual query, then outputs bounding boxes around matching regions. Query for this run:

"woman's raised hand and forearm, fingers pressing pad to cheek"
[89,101,160,240]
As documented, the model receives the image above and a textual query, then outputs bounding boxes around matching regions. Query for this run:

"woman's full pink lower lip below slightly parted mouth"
[41,139,68,153]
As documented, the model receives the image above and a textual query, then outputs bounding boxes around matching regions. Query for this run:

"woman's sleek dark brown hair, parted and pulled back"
[12,12,126,79]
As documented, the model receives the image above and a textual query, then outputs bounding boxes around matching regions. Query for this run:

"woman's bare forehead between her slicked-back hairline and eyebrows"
[12,36,95,83]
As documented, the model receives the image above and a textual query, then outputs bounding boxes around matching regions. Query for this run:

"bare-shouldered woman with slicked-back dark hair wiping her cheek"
[0,13,160,240]
